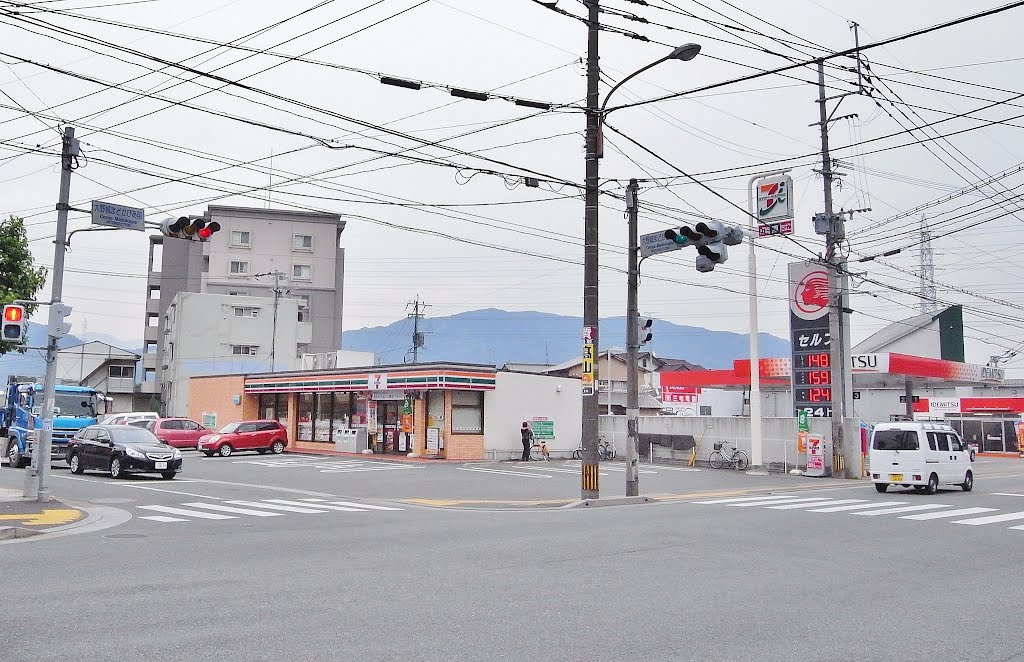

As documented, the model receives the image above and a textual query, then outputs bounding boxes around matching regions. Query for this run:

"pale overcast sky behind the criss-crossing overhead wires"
[0,0,1024,367]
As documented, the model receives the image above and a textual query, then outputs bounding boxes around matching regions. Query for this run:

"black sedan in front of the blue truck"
[67,425,181,480]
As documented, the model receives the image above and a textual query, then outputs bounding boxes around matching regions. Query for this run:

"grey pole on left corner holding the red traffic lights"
[25,126,78,503]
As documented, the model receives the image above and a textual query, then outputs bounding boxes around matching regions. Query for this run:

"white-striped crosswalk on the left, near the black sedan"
[136,498,404,524]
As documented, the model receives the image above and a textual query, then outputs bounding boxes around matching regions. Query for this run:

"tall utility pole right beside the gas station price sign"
[818,59,846,478]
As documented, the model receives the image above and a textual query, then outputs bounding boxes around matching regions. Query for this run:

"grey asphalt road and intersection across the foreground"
[0,454,1024,662]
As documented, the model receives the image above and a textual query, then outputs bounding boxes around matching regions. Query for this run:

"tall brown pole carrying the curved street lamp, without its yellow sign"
[580,0,601,499]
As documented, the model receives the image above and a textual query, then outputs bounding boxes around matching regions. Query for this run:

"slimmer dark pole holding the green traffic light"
[626,179,640,496]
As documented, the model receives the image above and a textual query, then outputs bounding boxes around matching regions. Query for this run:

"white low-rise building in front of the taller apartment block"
[163,292,298,416]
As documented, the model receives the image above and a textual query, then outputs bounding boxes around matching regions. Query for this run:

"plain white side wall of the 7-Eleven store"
[483,371,583,459]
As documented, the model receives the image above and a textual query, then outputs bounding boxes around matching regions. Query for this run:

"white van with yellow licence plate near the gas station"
[867,421,974,494]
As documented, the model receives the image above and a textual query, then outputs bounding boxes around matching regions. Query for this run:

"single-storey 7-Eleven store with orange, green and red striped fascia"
[188,363,580,460]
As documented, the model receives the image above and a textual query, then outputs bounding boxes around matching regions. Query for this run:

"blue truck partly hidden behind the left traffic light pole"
[0,377,109,468]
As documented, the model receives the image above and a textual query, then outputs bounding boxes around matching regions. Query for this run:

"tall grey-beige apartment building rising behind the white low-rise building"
[141,205,345,411]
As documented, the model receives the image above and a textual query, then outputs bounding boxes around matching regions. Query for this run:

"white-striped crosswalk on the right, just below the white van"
[689,493,1024,531]
